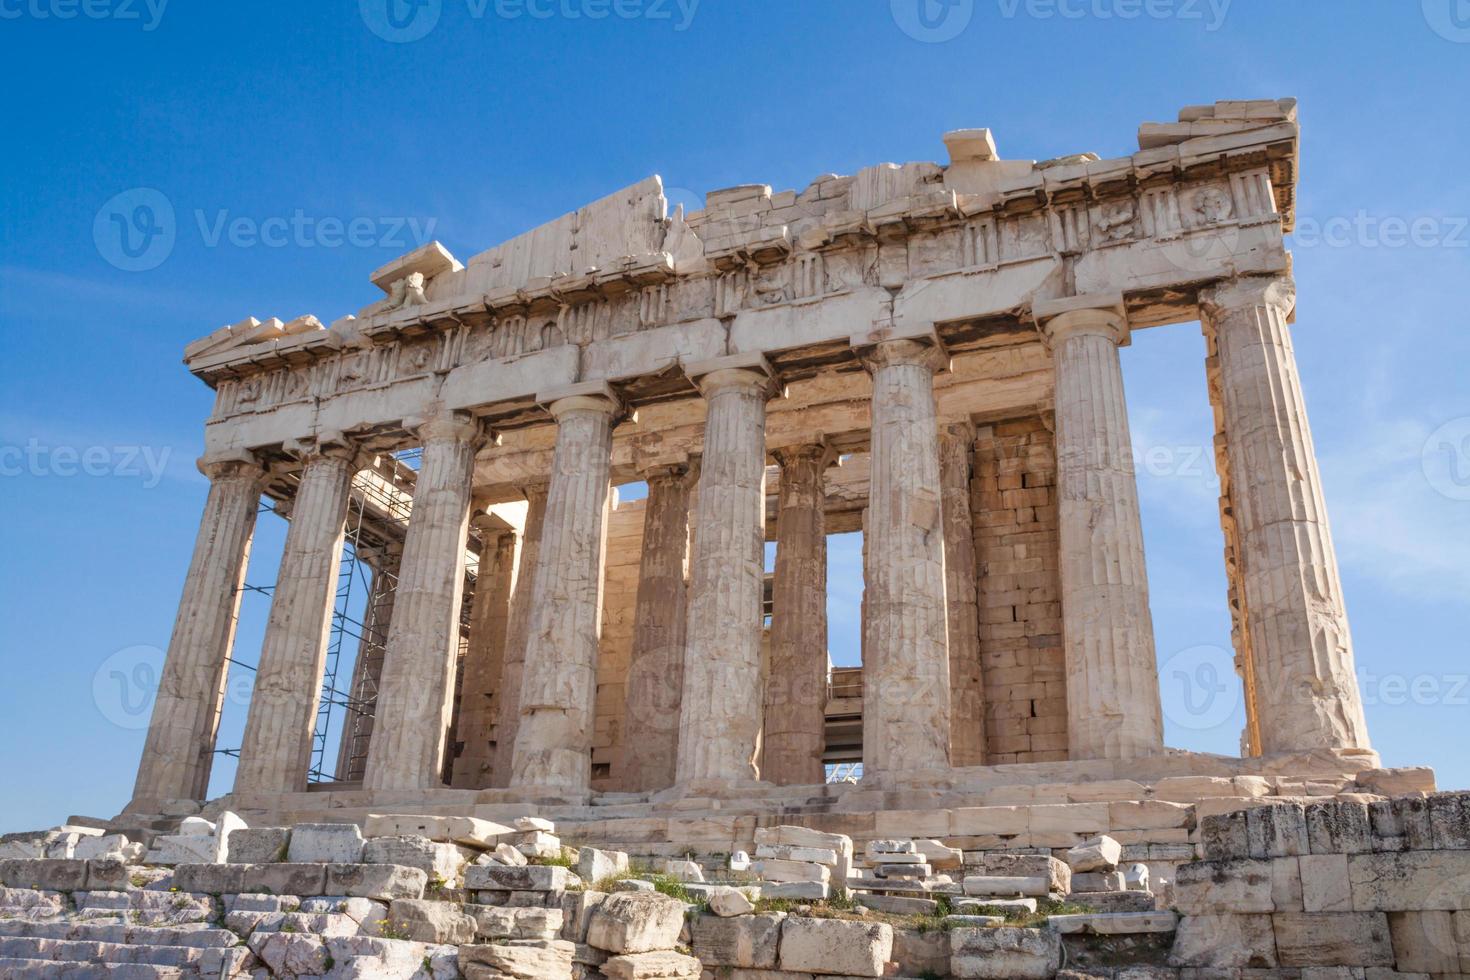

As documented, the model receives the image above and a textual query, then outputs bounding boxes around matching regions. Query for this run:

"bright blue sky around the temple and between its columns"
[0,0,1470,830]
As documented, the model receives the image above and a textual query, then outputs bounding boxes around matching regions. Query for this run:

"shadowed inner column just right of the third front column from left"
[450,513,520,789]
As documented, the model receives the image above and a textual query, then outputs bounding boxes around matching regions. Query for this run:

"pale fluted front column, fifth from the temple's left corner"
[676,369,772,785]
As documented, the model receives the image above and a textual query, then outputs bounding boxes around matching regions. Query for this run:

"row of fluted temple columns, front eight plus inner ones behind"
[135,281,1367,801]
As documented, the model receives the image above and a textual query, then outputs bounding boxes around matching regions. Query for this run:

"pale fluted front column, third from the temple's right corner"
[863,341,950,779]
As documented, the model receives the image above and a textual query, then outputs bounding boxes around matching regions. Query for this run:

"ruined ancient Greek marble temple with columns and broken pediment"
[129,100,1377,840]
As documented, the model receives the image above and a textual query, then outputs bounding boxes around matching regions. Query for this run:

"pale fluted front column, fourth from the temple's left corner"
[510,394,620,793]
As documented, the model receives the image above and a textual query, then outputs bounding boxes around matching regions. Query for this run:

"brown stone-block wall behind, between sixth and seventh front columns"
[972,416,1067,765]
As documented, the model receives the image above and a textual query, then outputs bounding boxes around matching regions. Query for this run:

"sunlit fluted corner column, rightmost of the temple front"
[1201,276,1369,754]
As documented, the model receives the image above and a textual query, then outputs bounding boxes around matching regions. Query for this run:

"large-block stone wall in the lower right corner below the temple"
[1170,793,1470,977]
